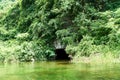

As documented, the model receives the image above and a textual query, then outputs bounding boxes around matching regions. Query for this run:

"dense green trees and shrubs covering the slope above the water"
[0,0,120,61]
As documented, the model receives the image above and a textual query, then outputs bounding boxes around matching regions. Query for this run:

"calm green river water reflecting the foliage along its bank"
[0,61,120,80]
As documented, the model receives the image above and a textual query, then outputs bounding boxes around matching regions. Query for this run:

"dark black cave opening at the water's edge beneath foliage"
[55,49,70,60]
